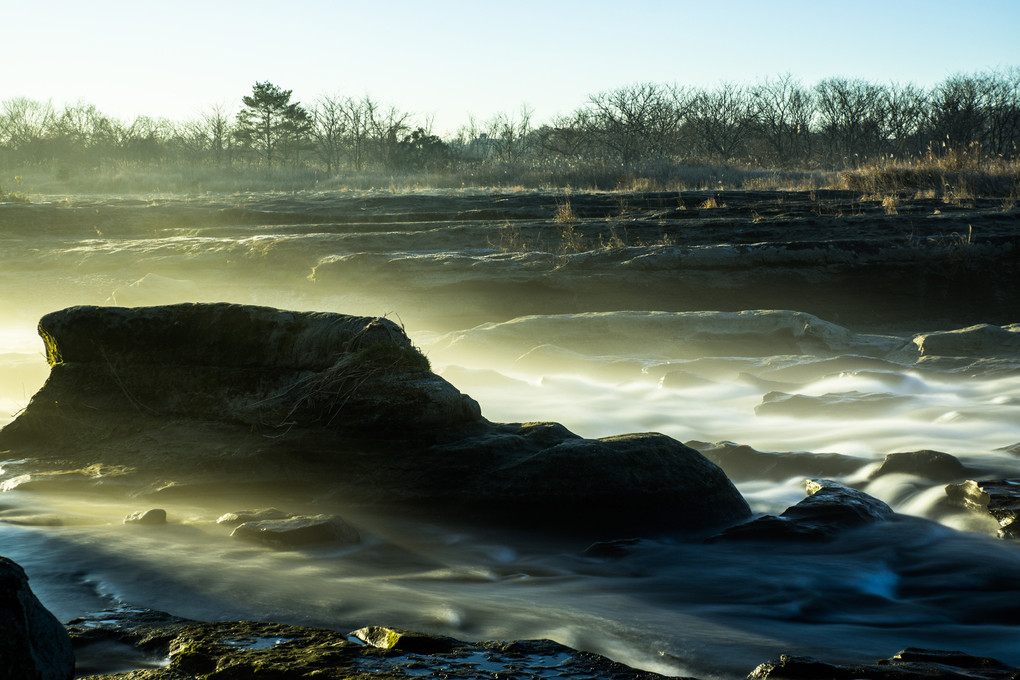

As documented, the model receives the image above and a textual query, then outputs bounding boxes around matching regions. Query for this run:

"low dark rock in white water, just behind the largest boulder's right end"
[687,441,867,481]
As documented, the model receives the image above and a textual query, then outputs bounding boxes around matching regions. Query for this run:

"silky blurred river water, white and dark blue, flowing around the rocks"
[0,191,1020,678]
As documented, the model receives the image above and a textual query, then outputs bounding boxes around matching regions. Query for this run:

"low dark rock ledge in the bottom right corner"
[748,647,1020,680]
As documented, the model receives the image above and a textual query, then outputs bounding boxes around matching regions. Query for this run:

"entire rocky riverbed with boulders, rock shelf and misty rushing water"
[0,191,1020,680]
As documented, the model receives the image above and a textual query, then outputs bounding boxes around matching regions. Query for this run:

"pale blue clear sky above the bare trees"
[0,0,1020,134]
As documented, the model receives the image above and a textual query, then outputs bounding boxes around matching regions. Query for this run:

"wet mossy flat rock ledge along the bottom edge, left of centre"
[71,622,693,680]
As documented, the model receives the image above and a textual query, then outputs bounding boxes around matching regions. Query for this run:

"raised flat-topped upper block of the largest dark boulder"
[12,303,480,431]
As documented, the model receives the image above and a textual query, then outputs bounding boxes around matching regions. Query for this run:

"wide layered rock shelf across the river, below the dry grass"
[0,190,1020,327]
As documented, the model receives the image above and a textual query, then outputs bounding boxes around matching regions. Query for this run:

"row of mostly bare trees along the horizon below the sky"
[0,67,1020,180]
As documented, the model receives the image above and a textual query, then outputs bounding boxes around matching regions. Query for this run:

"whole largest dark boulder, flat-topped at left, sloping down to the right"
[0,304,750,534]
